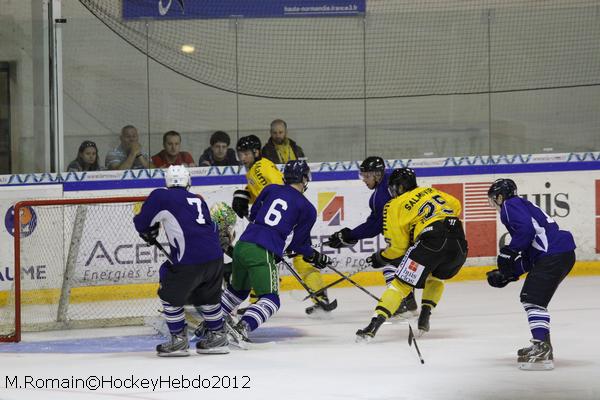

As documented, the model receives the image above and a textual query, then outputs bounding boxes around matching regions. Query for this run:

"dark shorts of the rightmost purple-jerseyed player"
[521,251,575,308]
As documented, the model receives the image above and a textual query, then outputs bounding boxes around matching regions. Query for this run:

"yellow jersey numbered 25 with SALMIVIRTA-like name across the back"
[381,187,461,259]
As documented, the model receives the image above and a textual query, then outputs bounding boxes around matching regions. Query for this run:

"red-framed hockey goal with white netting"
[0,197,167,341]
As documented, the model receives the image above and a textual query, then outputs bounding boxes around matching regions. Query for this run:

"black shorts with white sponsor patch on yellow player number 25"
[396,218,468,288]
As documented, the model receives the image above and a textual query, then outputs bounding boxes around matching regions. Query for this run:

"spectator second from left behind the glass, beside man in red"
[105,125,154,169]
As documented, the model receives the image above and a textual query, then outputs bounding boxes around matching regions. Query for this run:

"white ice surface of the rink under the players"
[0,277,600,400]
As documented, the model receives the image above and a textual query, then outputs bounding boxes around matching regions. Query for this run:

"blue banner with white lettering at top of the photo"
[123,0,367,20]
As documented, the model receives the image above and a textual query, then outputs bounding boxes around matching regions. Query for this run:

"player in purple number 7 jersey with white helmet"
[133,165,229,357]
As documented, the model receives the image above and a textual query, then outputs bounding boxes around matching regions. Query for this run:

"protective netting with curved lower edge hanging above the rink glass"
[80,0,600,99]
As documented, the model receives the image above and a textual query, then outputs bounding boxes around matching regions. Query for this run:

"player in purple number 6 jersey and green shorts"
[221,160,331,348]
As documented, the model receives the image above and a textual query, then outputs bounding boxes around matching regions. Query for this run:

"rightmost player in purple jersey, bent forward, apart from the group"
[487,179,576,370]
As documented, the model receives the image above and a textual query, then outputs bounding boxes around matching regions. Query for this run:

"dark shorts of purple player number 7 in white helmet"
[158,257,223,307]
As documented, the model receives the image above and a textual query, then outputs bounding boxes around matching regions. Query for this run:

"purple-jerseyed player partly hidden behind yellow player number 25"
[324,156,418,316]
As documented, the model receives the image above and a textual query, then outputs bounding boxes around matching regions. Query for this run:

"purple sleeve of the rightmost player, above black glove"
[500,201,535,252]
